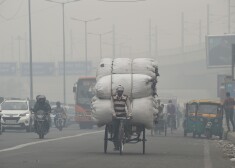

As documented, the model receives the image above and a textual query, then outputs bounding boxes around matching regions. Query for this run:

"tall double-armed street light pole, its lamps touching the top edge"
[46,0,80,104]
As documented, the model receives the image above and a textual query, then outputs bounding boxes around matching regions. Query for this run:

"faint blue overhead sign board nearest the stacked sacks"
[59,61,92,75]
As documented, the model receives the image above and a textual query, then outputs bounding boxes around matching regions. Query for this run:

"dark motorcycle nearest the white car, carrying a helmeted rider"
[35,110,49,139]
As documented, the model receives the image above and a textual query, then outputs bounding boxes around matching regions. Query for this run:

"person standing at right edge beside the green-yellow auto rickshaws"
[223,92,235,132]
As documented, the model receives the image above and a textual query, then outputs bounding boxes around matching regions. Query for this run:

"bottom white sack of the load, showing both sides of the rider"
[92,97,158,129]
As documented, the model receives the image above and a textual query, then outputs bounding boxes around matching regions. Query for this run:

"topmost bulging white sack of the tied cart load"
[96,58,158,80]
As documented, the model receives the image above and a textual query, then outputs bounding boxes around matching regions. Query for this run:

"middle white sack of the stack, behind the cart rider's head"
[95,74,153,99]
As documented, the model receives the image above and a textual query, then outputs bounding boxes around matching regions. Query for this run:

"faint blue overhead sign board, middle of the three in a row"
[21,62,55,76]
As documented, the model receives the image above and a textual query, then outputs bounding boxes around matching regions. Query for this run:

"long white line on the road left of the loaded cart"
[0,131,104,153]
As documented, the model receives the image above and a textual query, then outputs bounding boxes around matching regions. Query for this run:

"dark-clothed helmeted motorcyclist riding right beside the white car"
[33,95,51,132]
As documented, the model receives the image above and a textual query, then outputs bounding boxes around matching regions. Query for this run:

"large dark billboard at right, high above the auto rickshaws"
[206,34,235,67]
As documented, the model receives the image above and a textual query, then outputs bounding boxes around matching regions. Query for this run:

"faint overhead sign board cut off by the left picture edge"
[0,63,17,76]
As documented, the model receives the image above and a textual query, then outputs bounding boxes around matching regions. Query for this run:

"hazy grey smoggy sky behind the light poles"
[0,0,231,61]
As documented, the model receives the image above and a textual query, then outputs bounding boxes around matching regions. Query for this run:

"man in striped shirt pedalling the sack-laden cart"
[111,85,132,150]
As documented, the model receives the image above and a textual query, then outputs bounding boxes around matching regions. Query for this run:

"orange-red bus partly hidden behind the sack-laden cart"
[73,77,96,129]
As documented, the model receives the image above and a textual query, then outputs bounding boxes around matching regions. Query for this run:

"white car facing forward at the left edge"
[1,100,33,132]
